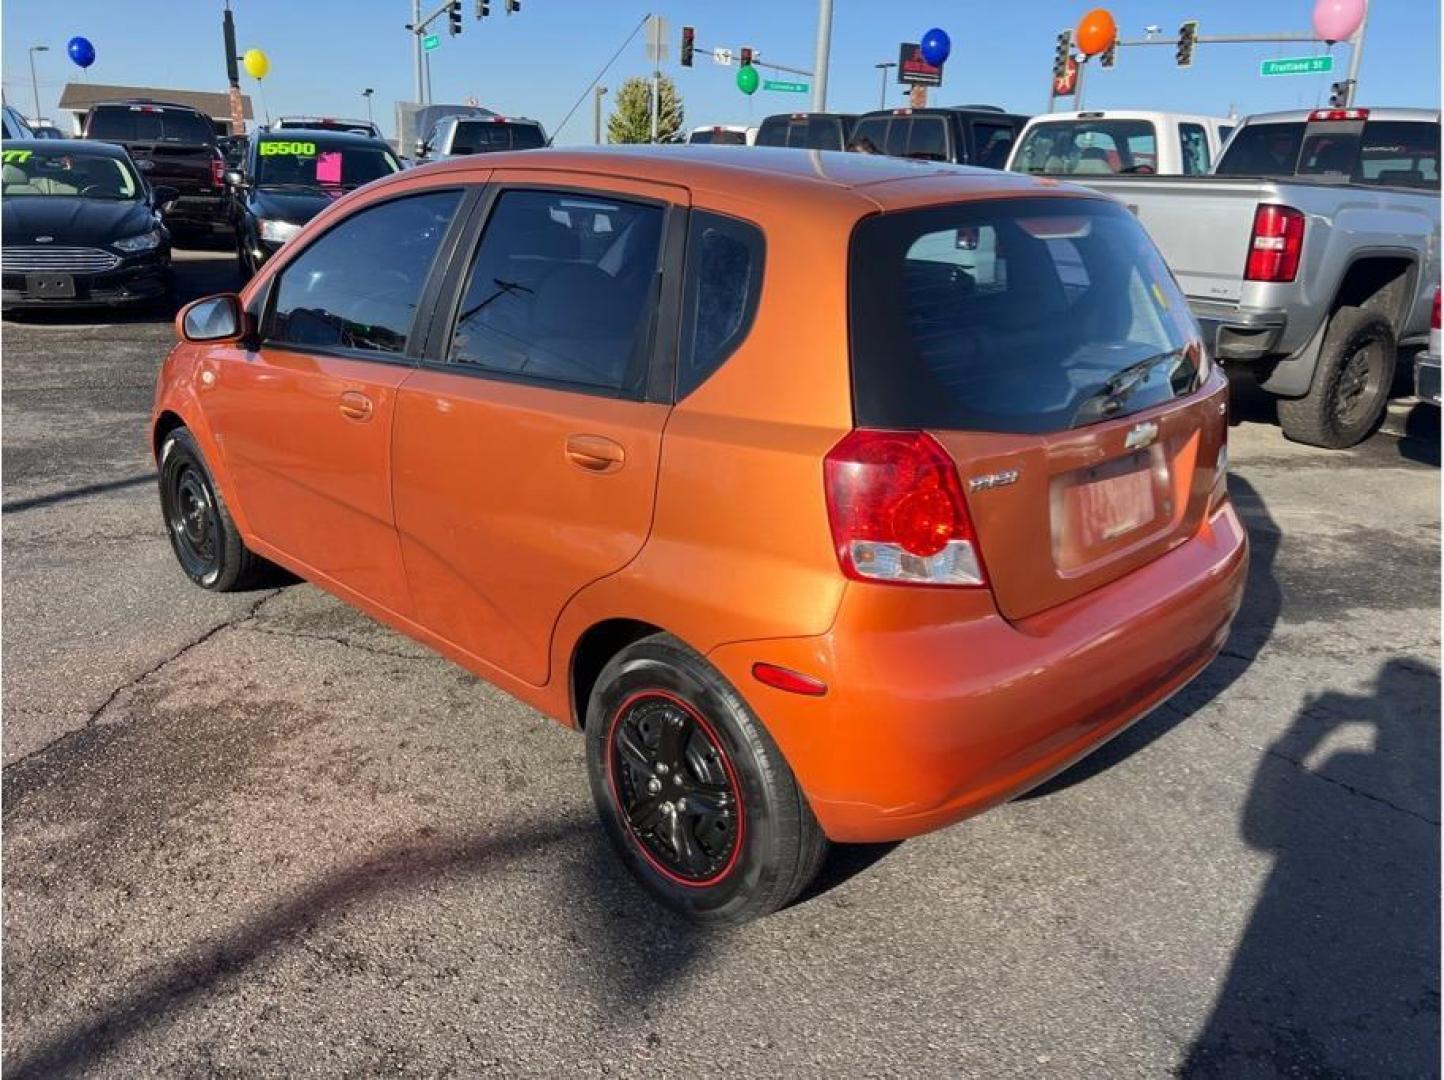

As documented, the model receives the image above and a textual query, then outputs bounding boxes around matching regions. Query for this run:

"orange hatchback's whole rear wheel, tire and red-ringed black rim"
[586,634,827,926]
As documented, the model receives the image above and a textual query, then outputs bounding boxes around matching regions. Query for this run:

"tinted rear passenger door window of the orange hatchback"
[449,191,664,394]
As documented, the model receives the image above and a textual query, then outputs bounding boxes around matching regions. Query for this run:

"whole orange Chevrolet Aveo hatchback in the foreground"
[152,147,1248,923]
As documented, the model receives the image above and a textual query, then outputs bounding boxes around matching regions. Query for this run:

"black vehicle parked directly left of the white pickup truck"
[848,105,1028,169]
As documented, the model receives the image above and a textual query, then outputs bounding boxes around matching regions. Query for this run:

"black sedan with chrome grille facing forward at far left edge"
[0,139,176,309]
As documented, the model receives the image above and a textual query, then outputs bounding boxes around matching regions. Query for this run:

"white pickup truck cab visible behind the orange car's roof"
[1006,108,1239,178]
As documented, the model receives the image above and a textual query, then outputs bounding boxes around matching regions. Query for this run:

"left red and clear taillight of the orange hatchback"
[823,429,988,588]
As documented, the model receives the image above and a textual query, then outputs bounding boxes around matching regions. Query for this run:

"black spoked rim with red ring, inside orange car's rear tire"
[608,690,747,885]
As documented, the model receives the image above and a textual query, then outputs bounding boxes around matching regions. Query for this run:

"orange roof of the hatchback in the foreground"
[398,143,1105,217]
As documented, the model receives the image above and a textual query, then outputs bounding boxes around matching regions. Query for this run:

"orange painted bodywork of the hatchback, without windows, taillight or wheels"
[155,149,1248,840]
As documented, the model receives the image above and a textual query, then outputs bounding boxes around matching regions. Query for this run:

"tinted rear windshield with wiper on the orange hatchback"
[849,199,1200,433]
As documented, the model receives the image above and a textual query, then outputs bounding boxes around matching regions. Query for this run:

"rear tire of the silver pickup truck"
[1278,308,1398,450]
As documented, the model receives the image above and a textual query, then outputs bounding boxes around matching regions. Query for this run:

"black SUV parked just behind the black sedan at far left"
[85,98,231,238]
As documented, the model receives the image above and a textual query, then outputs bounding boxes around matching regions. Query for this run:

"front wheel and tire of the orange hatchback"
[160,427,270,592]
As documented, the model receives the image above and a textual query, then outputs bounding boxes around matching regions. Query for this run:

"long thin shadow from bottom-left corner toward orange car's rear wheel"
[4,820,586,1080]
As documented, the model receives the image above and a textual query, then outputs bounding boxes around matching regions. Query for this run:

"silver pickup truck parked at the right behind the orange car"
[1051,108,1440,448]
